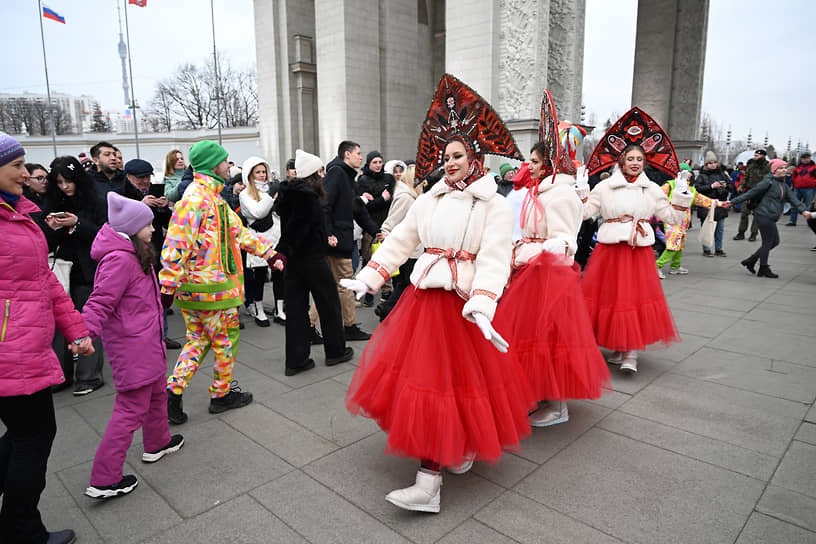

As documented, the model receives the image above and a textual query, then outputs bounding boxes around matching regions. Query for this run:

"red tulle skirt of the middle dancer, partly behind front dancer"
[493,252,609,400]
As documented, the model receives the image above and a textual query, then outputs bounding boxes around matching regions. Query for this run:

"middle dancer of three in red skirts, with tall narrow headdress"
[495,91,609,427]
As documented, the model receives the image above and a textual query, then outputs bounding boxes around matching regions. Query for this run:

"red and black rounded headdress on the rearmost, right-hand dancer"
[587,107,680,176]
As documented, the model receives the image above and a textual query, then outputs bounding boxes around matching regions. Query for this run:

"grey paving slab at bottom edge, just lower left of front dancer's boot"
[251,472,409,544]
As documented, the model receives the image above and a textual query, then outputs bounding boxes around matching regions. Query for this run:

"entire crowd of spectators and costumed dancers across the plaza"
[0,70,816,542]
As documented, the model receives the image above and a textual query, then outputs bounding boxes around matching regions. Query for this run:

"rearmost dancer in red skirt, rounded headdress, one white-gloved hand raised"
[581,108,694,373]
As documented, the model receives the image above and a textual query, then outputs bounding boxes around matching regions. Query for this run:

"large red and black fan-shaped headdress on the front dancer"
[416,74,524,183]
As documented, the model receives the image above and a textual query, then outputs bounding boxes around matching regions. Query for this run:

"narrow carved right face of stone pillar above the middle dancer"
[547,0,586,123]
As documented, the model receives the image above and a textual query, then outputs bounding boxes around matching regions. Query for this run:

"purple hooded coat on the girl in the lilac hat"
[82,223,167,391]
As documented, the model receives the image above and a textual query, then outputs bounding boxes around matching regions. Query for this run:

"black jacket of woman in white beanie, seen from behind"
[274,180,328,262]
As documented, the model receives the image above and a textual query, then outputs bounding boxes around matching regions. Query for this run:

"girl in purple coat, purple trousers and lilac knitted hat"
[82,192,184,499]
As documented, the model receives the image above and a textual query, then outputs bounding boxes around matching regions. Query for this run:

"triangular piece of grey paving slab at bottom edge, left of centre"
[140,495,308,544]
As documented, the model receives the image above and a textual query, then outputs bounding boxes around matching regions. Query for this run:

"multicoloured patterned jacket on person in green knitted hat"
[159,173,275,310]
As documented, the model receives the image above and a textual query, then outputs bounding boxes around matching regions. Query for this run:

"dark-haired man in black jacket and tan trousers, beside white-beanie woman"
[323,140,371,340]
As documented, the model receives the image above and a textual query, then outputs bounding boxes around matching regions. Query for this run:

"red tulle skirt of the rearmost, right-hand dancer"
[581,243,680,351]
